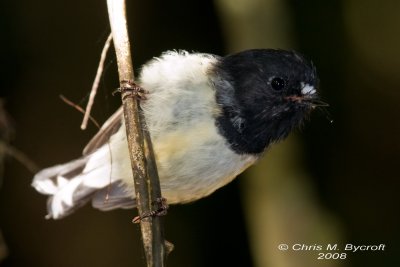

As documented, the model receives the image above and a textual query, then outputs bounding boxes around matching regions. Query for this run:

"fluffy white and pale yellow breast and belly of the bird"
[112,52,256,203]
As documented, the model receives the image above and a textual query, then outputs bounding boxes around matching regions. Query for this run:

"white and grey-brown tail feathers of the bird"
[32,147,136,219]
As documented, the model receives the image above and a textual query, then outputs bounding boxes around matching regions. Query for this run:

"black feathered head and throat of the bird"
[211,49,317,154]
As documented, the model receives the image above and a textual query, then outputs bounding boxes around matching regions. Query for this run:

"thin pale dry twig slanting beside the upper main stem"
[81,33,112,130]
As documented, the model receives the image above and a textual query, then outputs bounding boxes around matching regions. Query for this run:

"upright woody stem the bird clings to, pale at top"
[107,0,166,267]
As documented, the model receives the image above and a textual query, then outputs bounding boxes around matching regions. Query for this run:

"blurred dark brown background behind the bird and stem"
[0,0,400,267]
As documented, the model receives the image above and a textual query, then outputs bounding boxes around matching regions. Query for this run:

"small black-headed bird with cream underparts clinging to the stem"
[32,49,322,219]
